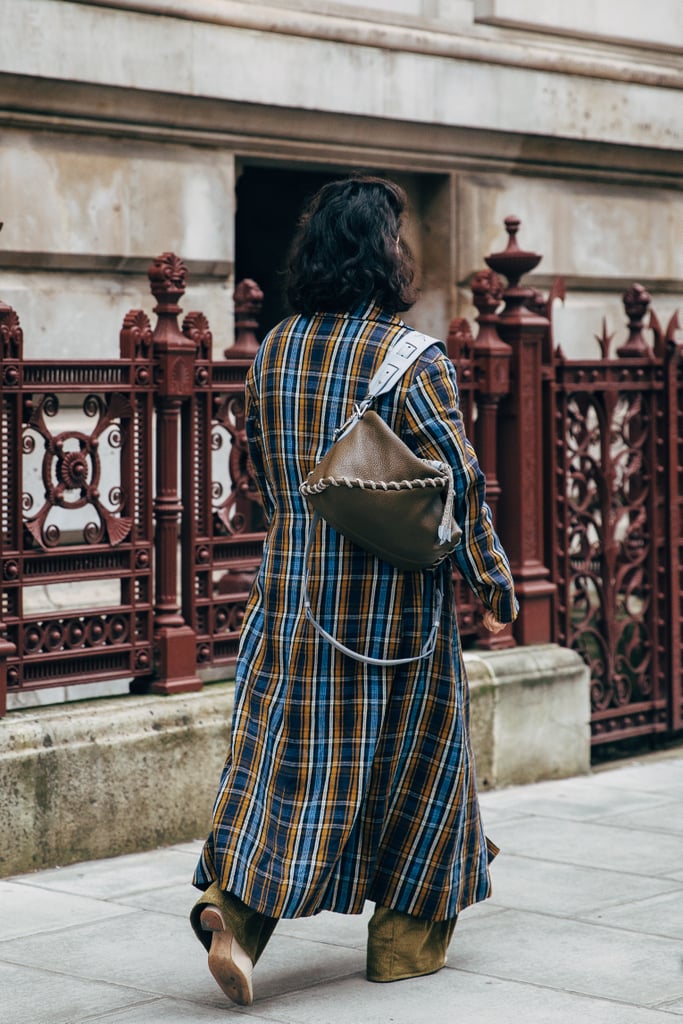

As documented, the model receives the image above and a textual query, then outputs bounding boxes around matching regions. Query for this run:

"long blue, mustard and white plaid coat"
[195,306,516,921]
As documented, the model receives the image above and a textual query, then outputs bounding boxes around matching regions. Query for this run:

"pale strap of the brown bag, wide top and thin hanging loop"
[303,330,443,666]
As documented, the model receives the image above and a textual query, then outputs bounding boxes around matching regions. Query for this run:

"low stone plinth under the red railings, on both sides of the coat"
[0,645,589,877]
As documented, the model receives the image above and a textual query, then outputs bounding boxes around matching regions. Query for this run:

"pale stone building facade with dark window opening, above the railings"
[0,0,683,358]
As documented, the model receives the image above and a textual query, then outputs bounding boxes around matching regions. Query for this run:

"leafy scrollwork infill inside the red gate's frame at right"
[565,392,653,711]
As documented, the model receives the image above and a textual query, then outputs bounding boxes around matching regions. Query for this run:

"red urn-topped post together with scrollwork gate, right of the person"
[462,224,683,745]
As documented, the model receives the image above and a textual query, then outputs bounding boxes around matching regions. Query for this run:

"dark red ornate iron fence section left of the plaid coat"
[0,253,272,714]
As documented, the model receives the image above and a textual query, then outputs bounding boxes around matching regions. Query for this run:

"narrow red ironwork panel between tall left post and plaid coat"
[182,280,265,670]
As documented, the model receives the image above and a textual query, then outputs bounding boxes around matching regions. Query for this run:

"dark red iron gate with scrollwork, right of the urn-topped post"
[554,337,680,743]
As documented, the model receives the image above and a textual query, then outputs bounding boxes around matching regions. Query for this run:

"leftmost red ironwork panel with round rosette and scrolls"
[0,299,154,708]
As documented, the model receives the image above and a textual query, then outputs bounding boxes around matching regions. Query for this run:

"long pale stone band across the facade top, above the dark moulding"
[0,0,682,148]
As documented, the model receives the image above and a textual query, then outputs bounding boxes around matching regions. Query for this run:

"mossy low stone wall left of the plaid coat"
[0,685,232,876]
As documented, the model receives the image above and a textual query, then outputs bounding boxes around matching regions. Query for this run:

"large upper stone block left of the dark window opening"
[0,129,234,269]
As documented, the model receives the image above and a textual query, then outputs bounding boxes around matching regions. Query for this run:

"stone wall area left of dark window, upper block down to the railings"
[0,129,234,359]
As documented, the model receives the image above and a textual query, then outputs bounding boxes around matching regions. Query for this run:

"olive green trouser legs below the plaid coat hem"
[189,883,457,981]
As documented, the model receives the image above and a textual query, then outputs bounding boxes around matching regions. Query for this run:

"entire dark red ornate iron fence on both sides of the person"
[0,228,683,743]
